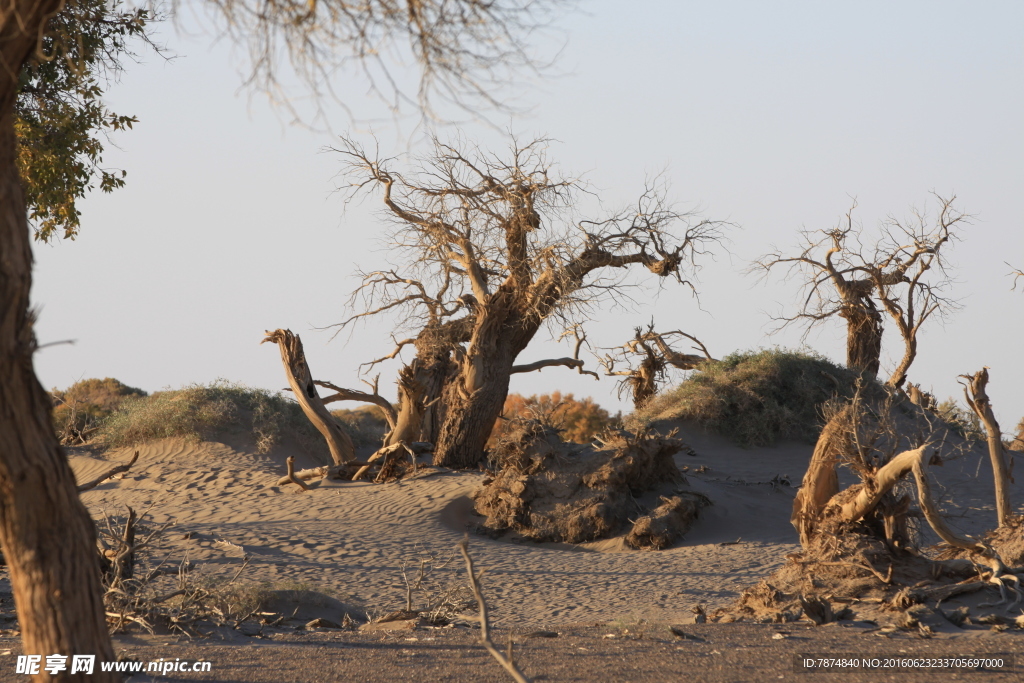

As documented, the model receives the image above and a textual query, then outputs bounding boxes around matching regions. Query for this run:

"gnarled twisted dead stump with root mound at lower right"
[723,373,1024,625]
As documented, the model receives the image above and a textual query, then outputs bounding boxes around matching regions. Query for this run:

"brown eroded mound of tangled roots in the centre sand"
[473,422,710,550]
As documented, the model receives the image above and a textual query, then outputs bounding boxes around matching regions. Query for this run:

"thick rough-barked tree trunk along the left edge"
[0,0,118,681]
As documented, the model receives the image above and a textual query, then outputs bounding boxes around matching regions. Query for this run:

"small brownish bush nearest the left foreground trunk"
[50,377,146,445]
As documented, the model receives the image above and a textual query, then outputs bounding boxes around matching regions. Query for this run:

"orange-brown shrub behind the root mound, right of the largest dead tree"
[487,391,621,449]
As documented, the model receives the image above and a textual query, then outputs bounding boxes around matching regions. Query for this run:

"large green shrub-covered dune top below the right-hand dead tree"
[625,349,857,447]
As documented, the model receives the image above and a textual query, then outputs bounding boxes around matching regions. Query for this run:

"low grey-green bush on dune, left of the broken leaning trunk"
[98,380,322,453]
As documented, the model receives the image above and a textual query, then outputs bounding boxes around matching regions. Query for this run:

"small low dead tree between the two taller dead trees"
[600,323,715,409]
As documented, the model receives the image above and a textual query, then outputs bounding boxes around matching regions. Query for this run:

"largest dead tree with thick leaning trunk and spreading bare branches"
[331,140,722,467]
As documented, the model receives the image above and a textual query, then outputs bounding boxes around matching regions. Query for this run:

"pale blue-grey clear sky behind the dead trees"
[33,0,1024,431]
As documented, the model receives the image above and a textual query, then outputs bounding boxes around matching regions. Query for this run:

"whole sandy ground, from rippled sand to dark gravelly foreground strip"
[0,426,1024,681]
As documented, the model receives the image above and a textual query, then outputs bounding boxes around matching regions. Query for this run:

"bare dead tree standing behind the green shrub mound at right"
[753,196,969,387]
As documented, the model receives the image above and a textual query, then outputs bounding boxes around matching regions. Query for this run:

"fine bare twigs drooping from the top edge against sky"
[199,0,564,124]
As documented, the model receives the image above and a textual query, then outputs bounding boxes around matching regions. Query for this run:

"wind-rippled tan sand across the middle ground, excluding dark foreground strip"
[71,425,1024,628]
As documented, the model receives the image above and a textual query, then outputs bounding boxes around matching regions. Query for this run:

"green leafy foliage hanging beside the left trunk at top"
[14,0,161,241]
